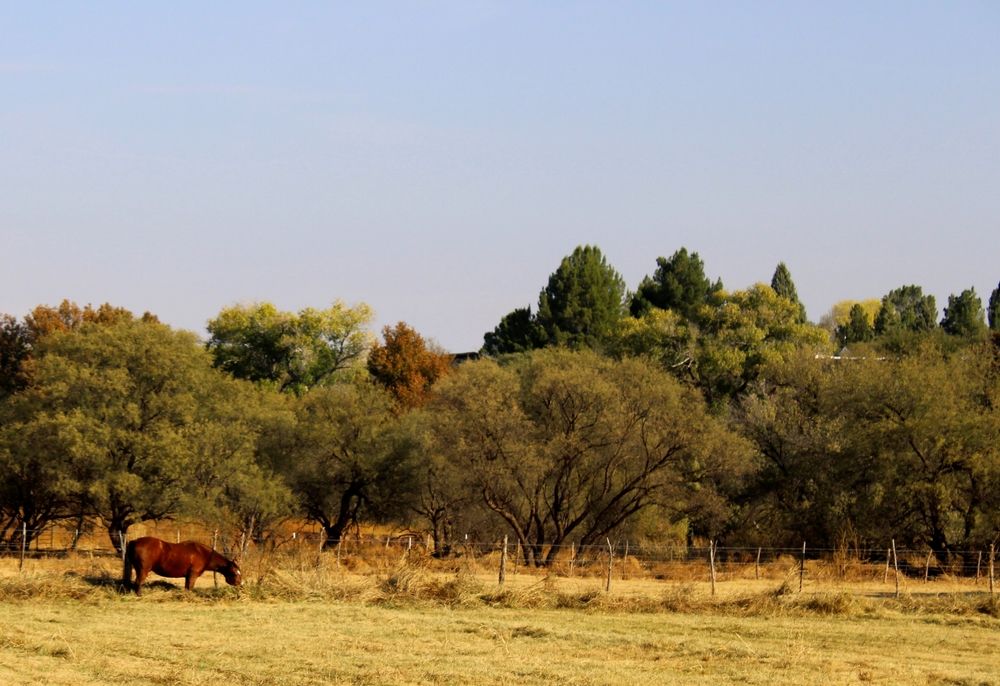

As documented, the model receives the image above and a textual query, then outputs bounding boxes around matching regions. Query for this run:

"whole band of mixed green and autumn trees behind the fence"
[0,246,1000,566]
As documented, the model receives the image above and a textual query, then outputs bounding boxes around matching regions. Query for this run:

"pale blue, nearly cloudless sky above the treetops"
[0,0,1000,352]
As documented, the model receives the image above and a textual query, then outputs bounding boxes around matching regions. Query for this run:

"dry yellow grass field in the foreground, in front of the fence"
[0,554,1000,686]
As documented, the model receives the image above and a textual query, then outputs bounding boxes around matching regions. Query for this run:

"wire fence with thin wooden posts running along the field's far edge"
[0,524,995,581]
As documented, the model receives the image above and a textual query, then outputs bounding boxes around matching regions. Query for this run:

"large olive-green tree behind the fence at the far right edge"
[844,345,1000,558]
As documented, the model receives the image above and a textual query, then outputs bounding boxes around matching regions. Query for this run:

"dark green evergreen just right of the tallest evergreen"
[630,248,722,319]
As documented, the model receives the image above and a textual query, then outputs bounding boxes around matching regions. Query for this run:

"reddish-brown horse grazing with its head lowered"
[122,536,242,595]
